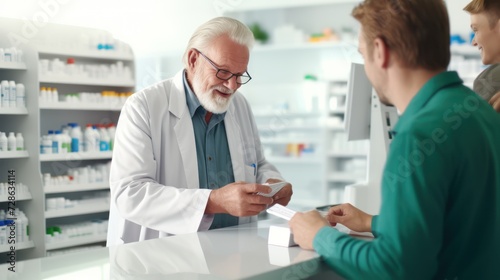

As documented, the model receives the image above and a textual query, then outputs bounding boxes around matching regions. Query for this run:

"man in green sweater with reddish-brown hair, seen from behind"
[290,0,500,280]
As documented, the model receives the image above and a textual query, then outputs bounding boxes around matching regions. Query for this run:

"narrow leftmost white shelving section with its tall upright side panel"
[0,19,45,263]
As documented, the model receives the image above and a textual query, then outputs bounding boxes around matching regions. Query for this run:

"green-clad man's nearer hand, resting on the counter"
[288,211,329,250]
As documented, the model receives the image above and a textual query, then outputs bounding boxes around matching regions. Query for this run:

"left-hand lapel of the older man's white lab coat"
[169,71,199,189]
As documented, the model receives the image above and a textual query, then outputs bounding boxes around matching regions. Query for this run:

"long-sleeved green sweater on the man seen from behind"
[314,72,500,280]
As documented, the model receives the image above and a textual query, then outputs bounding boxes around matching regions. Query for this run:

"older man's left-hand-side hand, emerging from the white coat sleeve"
[205,182,273,217]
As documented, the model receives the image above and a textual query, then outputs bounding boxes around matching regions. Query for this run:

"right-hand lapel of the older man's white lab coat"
[224,105,246,182]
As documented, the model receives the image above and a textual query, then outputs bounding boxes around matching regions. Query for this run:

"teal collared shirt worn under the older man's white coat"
[183,71,239,229]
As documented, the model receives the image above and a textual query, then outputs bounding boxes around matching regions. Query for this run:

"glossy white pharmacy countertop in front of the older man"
[0,219,344,280]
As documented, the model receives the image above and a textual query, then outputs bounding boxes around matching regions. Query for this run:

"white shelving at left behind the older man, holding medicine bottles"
[0,19,135,262]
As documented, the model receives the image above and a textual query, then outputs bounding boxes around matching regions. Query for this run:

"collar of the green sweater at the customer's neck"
[394,71,463,131]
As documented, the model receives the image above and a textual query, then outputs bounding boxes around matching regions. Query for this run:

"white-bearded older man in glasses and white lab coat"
[108,18,292,245]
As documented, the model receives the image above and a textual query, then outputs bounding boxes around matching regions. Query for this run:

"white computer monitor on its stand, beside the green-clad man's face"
[344,63,399,215]
